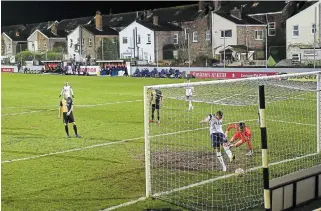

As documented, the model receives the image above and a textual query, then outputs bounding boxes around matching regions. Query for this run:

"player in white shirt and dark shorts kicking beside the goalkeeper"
[200,111,235,171]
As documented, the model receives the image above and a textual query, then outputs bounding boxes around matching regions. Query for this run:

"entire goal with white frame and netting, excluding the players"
[144,72,321,210]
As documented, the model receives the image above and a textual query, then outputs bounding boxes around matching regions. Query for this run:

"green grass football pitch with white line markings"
[1,74,321,211]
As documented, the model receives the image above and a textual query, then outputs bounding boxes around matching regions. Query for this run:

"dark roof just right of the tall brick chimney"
[102,11,144,28]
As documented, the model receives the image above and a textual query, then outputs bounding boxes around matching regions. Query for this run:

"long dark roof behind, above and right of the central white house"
[147,4,201,23]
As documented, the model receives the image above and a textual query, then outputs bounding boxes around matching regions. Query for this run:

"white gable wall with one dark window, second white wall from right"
[212,13,237,55]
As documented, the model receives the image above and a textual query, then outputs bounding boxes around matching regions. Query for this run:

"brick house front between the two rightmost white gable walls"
[236,26,265,50]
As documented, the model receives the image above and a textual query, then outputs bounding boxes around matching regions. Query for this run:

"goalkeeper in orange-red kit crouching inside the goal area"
[225,122,253,156]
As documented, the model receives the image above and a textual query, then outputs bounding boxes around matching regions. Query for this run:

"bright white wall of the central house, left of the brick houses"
[119,22,155,63]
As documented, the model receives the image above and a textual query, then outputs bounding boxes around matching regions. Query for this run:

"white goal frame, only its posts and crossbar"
[144,71,321,198]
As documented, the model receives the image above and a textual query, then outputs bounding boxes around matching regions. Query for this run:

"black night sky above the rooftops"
[1,0,197,26]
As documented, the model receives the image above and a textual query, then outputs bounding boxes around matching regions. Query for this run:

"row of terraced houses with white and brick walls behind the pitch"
[1,1,321,64]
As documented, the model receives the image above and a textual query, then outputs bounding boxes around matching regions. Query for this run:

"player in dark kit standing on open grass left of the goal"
[58,93,80,138]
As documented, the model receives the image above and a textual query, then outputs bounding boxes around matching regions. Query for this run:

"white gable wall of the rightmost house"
[286,2,321,59]
